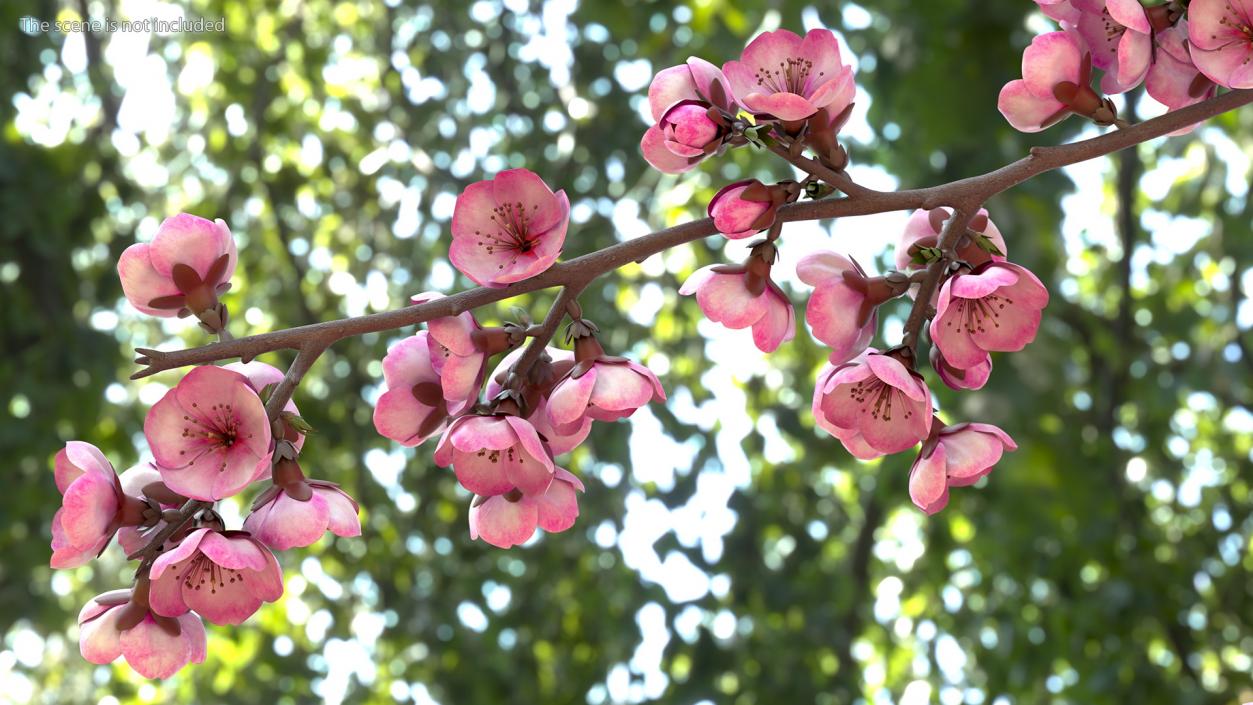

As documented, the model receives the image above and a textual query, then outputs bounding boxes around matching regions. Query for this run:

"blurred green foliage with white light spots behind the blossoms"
[0,0,1253,705]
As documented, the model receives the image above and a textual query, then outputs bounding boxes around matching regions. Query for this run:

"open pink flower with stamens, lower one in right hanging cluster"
[813,348,931,460]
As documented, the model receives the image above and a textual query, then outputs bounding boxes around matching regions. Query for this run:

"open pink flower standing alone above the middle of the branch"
[449,169,570,287]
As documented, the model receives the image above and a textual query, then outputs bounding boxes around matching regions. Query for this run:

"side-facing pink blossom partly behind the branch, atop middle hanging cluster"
[410,292,488,406]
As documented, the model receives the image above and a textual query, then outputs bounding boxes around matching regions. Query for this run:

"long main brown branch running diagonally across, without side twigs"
[124,90,1253,379]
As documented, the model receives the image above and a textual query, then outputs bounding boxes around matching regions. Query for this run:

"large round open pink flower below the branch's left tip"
[144,366,272,502]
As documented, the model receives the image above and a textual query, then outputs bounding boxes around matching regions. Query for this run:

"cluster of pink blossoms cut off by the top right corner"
[999,0,1253,133]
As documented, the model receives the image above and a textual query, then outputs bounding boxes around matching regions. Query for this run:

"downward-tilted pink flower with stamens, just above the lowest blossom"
[149,528,283,625]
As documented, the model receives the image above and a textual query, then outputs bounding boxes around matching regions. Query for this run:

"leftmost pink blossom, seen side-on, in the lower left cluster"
[51,441,147,569]
